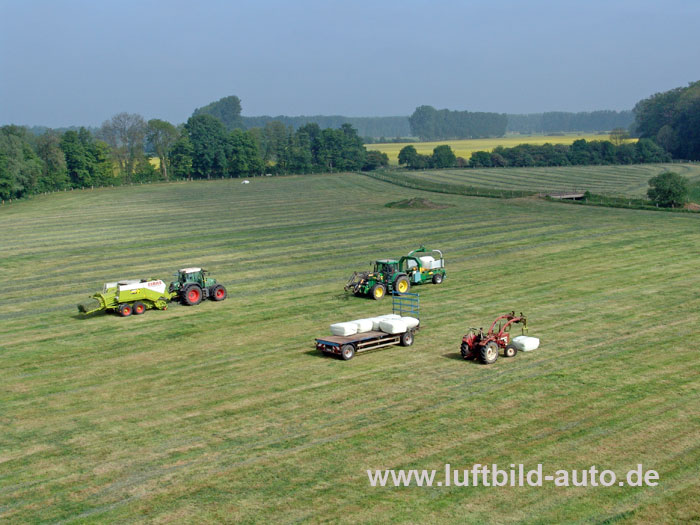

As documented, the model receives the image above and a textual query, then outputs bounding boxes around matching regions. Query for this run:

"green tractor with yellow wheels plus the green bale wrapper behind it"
[345,246,445,300]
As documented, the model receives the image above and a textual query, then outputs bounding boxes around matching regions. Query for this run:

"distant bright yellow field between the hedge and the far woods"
[366,133,624,165]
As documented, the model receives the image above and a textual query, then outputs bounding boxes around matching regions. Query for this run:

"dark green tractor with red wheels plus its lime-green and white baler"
[78,268,227,317]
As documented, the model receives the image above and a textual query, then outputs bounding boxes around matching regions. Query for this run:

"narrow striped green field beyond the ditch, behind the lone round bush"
[380,163,700,198]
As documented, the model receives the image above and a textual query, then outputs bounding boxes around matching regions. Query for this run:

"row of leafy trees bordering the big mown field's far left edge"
[0,113,389,200]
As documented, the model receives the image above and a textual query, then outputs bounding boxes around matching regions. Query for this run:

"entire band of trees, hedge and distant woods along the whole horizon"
[0,81,700,201]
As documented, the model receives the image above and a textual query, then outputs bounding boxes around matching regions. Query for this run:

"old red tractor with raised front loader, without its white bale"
[461,312,527,365]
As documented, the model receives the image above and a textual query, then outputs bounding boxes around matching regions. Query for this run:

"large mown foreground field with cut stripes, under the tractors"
[0,175,700,523]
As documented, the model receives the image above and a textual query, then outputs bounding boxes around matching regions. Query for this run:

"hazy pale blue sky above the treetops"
[0,0,700,127]
